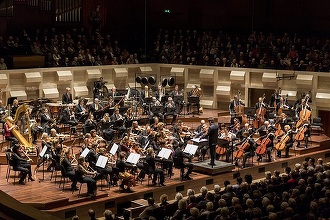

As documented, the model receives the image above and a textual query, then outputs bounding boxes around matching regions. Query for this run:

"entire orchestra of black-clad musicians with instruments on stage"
[4,80,322,196]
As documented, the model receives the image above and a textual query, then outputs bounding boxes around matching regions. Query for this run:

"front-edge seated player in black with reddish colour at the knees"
[116,152,136,192]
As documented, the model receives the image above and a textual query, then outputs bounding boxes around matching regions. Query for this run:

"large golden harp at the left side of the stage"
[5,104,36,152]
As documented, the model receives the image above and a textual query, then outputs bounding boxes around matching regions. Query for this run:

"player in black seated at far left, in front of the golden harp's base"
[11,144,34,185]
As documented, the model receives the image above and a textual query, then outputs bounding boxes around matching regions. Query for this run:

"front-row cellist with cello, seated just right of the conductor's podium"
[233,131,256,168]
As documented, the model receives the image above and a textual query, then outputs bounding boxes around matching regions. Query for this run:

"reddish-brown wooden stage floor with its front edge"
[0,110,330,219]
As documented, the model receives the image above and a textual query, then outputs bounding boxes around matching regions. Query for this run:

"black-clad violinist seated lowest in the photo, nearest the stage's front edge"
[76,156,97,197]
